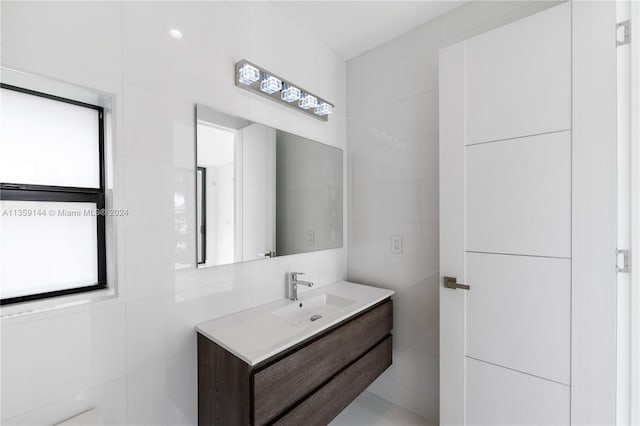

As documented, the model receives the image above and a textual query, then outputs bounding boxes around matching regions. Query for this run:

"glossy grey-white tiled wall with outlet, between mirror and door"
[347,1,554,424]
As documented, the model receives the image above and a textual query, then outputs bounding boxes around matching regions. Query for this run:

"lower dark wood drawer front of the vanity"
[275,335,392,426]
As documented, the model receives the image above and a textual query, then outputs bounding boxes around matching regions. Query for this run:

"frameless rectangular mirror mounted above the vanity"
[195,105,343,267]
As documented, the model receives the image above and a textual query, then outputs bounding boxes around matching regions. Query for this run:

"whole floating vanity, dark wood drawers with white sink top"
[196,281,393,425]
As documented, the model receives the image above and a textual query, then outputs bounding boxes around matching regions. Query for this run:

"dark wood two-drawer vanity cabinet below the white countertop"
[198,299,393,426]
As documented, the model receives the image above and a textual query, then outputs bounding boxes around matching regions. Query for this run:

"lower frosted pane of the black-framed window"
[0,200,98,299]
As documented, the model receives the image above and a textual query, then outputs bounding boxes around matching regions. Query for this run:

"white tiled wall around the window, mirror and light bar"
[1,2,346,425]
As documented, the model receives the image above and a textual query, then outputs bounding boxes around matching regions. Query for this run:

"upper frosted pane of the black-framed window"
[0,89,100,188]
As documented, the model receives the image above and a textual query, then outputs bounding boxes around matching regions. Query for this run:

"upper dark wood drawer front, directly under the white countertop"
[252,300,393,425]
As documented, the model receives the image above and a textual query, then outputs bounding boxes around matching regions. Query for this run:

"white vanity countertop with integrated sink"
[196,281,394,365]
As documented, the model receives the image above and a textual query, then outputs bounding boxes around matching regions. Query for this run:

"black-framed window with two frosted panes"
[0,84,107,305]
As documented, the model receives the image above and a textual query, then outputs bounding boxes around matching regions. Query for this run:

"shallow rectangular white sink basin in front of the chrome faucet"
[272,293,354,325]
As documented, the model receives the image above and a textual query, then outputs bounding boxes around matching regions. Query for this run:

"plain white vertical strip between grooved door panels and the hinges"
[571,2,618,425]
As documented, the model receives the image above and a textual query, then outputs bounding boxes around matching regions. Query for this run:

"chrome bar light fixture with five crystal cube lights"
[234,59,334,121]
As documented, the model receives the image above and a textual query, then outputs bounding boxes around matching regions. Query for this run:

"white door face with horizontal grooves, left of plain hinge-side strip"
[439,3,572,425]
